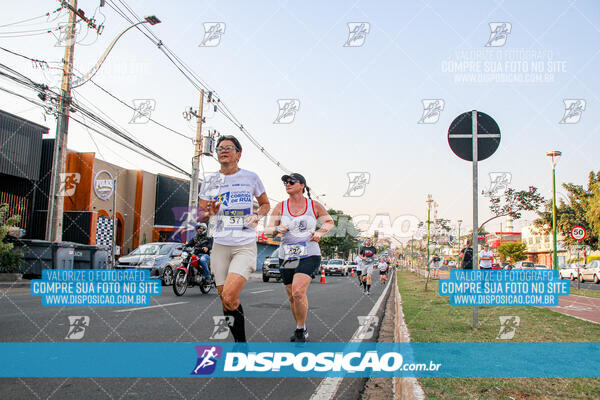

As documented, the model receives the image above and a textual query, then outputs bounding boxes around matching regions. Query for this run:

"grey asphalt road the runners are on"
[0,274,384,400]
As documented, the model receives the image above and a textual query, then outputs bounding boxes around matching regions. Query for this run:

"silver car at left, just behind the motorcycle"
[115,242,183,286]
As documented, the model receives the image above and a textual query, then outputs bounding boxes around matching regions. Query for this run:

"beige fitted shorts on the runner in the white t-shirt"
[210,242,257,286]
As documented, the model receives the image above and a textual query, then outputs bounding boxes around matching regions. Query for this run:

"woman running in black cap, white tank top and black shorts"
[265,173,334,342]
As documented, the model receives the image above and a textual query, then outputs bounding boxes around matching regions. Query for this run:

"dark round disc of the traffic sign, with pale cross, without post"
[448,111,500,161]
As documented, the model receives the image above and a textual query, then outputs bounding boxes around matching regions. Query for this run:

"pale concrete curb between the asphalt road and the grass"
[390,274,425,400]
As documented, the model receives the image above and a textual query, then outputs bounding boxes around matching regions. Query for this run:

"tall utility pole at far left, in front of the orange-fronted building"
[46,0,77,242]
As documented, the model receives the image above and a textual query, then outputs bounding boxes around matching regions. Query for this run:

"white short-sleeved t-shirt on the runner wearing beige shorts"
[200,169,265,246]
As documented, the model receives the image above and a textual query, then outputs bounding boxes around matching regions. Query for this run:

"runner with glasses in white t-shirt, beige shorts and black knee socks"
[199,135,271,342]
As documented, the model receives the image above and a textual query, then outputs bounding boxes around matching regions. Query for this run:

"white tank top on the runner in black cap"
[279,198,321,260]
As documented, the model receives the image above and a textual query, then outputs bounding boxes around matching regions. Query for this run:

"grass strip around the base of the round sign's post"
[398,272,600,399]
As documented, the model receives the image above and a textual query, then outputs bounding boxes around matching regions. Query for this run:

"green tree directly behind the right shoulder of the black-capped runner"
[319,209,360,257]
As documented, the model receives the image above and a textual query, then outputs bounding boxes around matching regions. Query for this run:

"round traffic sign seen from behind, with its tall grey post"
[448,110,500,328]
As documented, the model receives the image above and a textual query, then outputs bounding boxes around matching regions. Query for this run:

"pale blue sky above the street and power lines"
[0,0,600,239]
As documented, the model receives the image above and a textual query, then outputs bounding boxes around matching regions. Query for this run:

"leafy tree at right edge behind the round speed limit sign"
[534,171,600,250]
